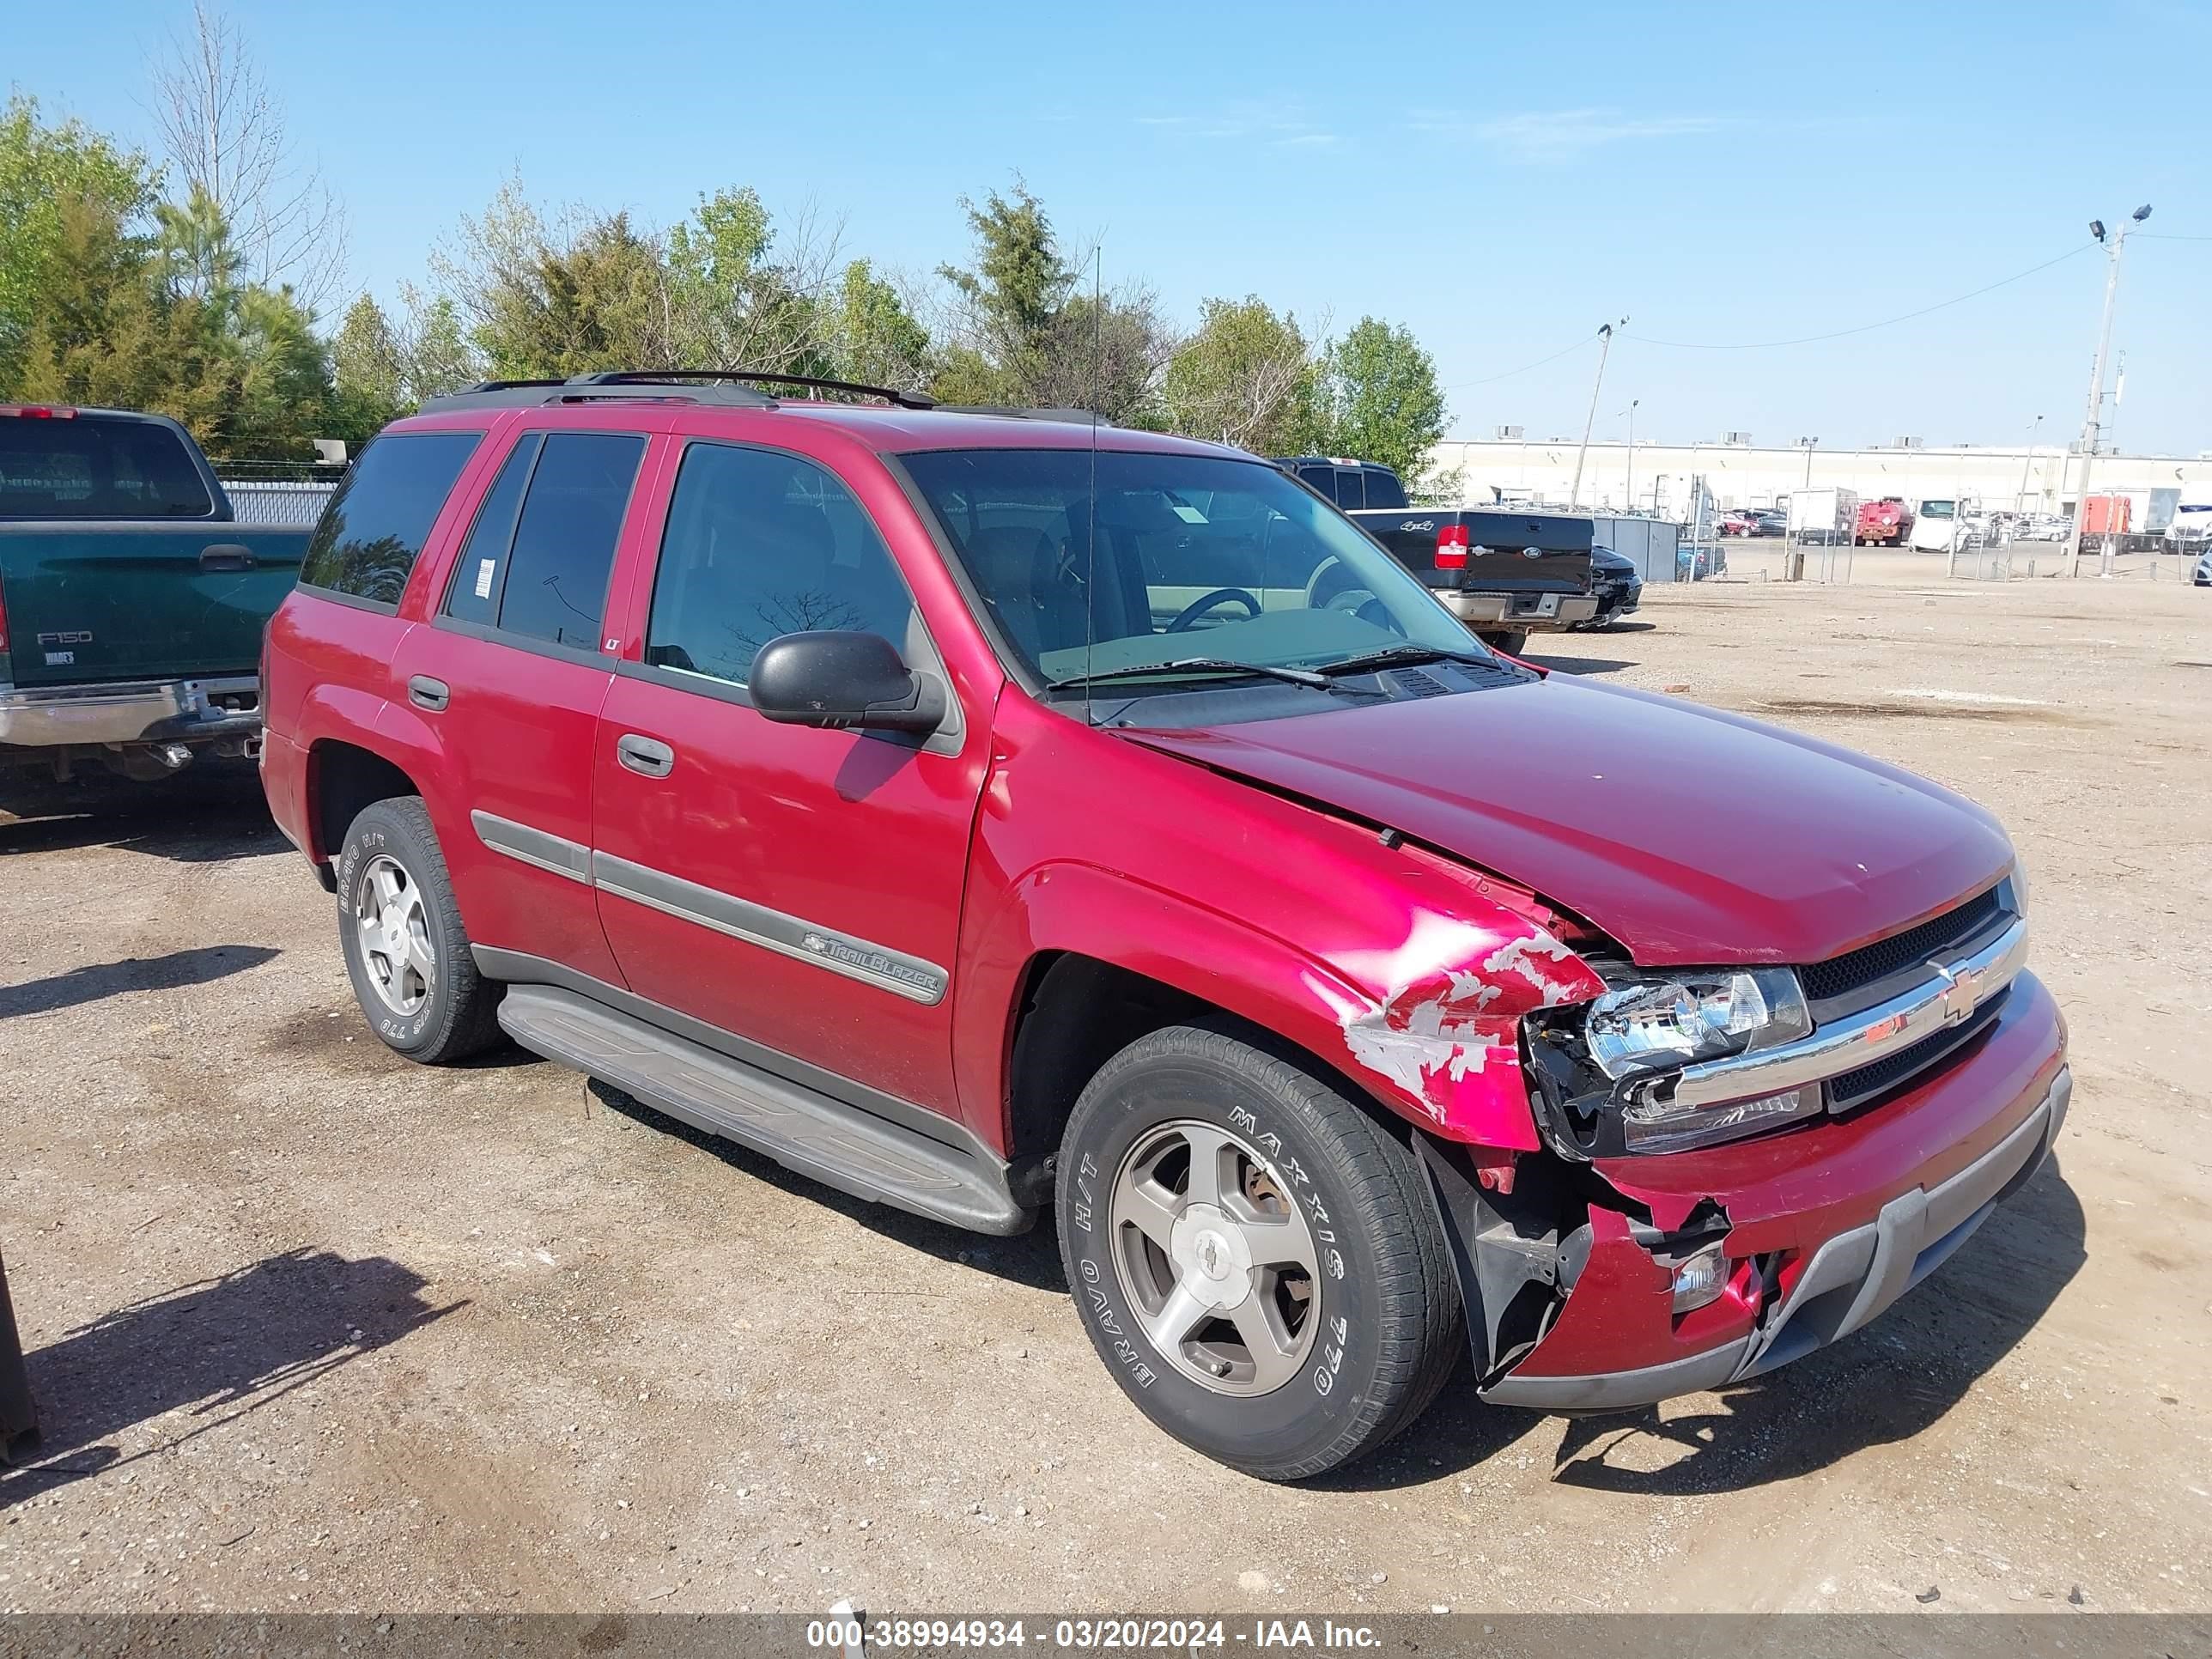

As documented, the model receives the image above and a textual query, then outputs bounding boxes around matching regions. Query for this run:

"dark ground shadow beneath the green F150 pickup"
[0,761,289,865]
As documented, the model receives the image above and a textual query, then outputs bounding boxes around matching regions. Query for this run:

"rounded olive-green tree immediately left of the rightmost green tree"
[1161,295,1316,456]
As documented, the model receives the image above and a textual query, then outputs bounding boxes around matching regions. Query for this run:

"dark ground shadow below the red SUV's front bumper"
[1555,1159,2088,1498]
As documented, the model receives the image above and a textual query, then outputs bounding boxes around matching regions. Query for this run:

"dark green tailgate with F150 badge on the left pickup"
[0,520,310,686]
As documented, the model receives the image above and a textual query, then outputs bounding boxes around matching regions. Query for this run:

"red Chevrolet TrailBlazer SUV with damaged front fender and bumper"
[264,376,2070,1480]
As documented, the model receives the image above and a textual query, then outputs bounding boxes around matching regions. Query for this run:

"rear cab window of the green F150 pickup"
[0,414,215,518]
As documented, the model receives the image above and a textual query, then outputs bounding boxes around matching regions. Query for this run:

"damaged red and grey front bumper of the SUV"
[1478,973,2073,1411]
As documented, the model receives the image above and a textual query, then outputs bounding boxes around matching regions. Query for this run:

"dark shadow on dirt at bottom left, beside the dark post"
[0,1248,467,1509]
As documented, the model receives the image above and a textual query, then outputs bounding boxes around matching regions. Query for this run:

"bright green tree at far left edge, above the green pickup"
[0,95,153,392]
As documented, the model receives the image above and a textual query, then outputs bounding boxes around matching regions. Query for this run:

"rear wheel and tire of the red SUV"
[338,794,500,1066]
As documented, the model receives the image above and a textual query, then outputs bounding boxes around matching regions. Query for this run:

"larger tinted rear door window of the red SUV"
[486,431,646,653]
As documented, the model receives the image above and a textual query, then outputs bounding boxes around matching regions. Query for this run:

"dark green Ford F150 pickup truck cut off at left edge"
[0,403,310,781]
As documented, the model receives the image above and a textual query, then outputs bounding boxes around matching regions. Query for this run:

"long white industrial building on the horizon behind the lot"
[1431,427,2212,518]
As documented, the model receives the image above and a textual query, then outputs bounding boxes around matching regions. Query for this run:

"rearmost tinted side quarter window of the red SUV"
[299,431,484,606]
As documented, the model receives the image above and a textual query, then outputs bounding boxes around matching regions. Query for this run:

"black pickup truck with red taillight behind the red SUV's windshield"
[1274,456,1597,653]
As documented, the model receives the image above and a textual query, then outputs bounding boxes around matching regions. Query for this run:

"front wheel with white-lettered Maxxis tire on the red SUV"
[1057,1026,1462,1480]
